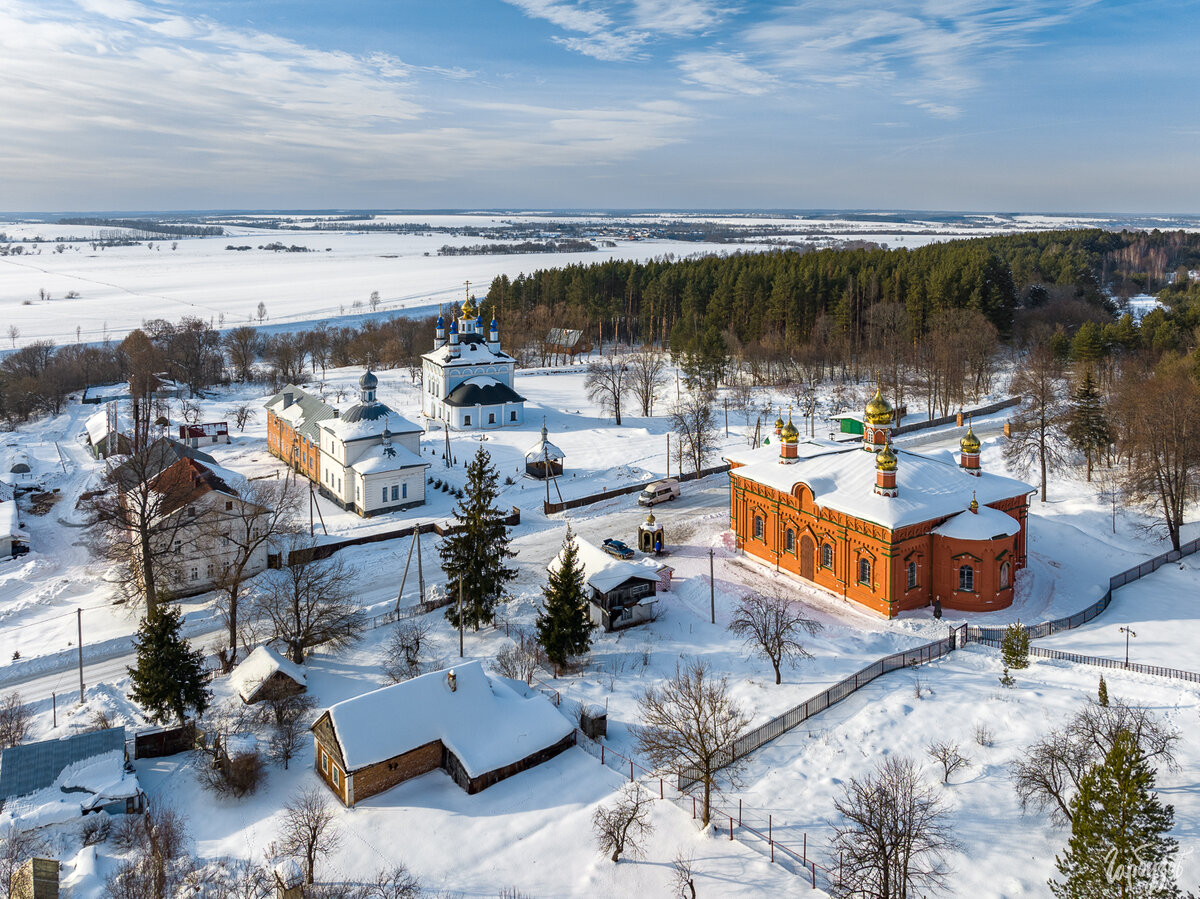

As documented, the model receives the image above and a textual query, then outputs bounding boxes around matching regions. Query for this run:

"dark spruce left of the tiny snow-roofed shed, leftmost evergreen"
[126,607,212,724]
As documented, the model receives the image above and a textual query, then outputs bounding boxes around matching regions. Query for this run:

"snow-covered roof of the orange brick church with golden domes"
[730,443,1034,528]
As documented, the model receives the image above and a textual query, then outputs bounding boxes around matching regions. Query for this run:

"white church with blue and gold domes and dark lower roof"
[421,296,524,431]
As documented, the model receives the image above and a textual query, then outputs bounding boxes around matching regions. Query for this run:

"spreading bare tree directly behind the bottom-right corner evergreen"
[1009,699,1180,823]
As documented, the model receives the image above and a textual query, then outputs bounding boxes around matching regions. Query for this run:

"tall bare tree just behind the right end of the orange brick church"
[1004,347,1067,503]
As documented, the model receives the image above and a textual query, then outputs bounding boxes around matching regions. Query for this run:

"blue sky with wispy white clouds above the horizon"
[0,0,1200,214]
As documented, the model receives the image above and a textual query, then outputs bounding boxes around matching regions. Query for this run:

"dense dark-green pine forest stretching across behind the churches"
[487,229,1200,349]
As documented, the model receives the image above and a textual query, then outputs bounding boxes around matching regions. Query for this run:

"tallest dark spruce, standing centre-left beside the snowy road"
[438,446,517,630]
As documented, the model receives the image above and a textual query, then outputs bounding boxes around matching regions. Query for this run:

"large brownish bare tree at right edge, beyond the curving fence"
[1116,359,1200,550]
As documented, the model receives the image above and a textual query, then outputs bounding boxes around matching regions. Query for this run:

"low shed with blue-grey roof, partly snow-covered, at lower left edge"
[0,726,145,831]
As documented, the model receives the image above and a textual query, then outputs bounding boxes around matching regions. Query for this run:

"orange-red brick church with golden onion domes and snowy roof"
[726,390,1034,618]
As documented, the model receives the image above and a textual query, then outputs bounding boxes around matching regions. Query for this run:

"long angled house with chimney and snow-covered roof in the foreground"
[312,661,575,807]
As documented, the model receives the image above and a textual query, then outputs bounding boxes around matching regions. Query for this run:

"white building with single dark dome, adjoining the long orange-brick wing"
[318,371,430,516]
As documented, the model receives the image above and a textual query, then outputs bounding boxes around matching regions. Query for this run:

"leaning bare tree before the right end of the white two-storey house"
[204,478,300,671]
